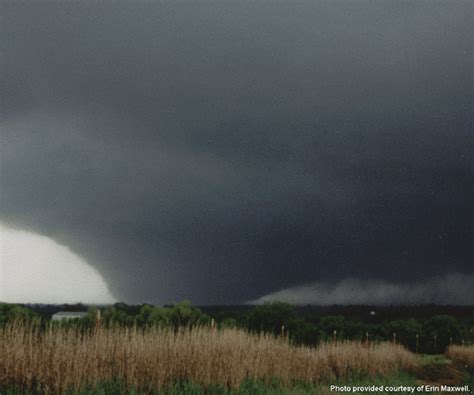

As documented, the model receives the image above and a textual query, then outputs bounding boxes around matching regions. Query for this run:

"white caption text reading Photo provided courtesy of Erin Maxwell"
[329,384,473,394]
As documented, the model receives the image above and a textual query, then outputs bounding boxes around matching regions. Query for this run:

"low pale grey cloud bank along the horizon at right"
[249,273,474,305]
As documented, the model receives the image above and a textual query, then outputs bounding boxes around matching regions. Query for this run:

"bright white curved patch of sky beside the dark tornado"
[0,223,114,303]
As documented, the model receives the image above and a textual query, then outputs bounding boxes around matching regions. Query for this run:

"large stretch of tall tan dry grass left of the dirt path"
[0,324,415,393]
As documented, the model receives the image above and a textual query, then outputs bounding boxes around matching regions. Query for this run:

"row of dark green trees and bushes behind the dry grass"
[0,301,474,353]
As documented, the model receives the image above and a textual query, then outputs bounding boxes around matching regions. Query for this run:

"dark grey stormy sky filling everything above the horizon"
[0,0,474,304]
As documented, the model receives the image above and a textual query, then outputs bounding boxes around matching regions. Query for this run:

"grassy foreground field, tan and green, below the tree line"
[0,321,474,395]
